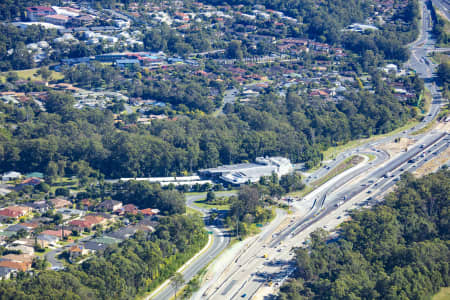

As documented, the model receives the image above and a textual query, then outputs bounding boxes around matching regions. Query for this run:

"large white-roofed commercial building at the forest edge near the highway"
[198,157,293,185]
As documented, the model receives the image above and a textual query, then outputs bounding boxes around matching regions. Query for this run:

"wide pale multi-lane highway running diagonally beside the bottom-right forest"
[201,133,450,299]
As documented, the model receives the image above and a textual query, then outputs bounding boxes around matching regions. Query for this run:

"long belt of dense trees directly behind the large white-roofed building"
[0,75,413,178]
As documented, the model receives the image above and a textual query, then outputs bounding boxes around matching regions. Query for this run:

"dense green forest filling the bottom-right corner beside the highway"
[279,170,450,299]
